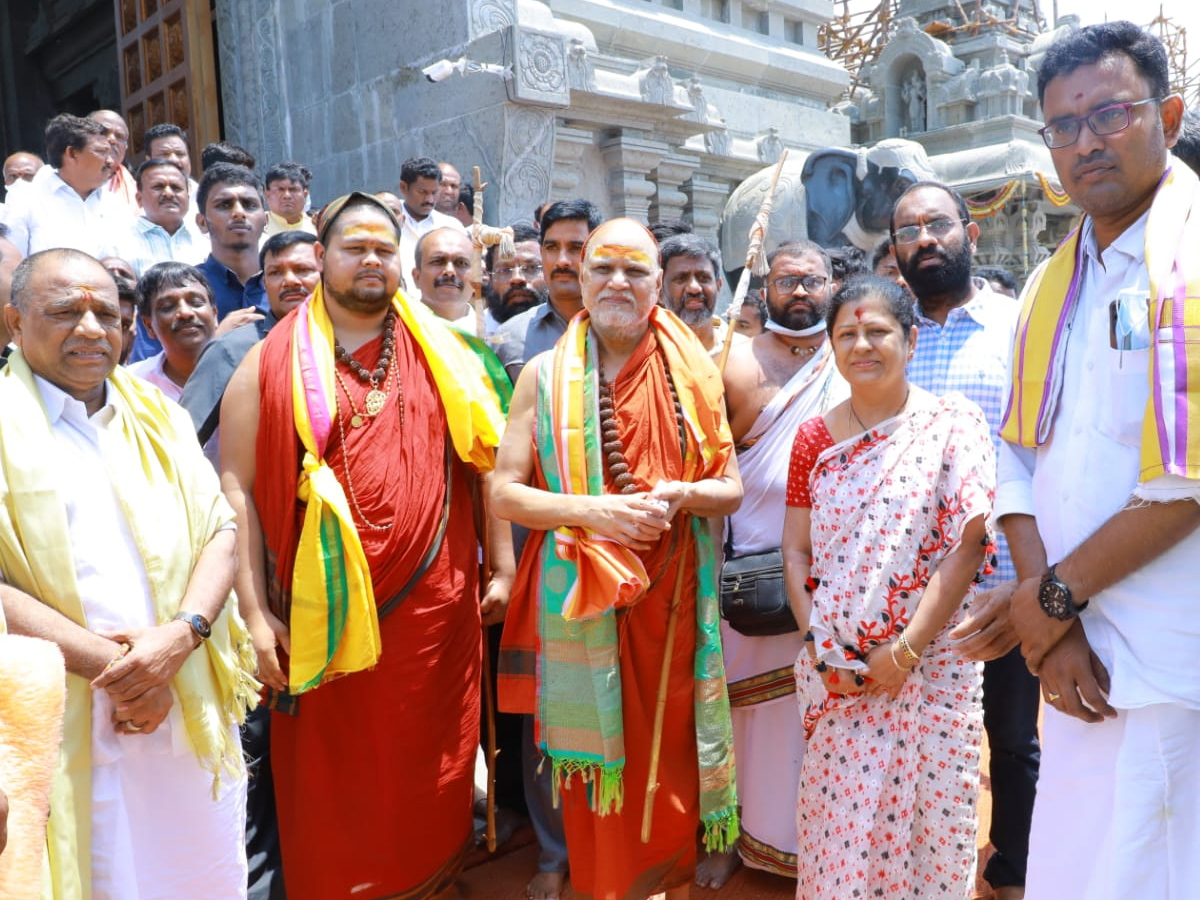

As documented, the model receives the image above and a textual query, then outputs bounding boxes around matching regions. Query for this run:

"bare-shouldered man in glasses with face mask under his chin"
[696,240,847,888]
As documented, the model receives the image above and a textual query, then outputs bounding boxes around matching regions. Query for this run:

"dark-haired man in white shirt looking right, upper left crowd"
[5,113,131,257]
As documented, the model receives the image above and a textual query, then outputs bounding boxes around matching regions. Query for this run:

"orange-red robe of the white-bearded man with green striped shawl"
[500,334,700,900]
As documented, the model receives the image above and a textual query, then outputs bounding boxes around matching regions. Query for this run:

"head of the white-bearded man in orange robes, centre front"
[580,218,662,341]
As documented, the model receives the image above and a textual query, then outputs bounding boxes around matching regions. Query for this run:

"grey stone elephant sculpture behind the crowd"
[720,138,937,284]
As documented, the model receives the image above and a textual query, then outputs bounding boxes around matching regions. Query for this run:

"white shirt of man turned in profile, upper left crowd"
[5,166,132,257]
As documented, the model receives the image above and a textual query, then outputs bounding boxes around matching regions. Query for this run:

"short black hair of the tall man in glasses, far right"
[1038,22,1171,103]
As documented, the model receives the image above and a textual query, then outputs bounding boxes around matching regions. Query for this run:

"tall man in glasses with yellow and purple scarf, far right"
[996,22,1200,900]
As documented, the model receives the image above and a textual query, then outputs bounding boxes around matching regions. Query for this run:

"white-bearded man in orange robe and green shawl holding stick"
[492,218,742,900]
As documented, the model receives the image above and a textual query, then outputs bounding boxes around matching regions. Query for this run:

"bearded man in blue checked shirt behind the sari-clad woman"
[890,181,1039,900]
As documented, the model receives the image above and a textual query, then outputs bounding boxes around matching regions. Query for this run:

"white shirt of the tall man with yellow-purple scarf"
[996,214,1200,709]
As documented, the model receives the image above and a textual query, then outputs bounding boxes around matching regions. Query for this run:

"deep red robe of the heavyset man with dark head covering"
[254,318,481,900]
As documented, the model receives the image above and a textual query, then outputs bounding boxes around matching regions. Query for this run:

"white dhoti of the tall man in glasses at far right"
[1025,703,1200,900]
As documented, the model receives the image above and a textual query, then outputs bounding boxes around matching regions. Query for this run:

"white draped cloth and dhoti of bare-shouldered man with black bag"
[721,343,847,877]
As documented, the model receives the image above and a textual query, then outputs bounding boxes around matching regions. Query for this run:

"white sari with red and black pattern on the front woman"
[790,395,995,900]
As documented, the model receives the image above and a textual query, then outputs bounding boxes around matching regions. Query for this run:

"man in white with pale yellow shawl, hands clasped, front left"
[0,251,254,900]
